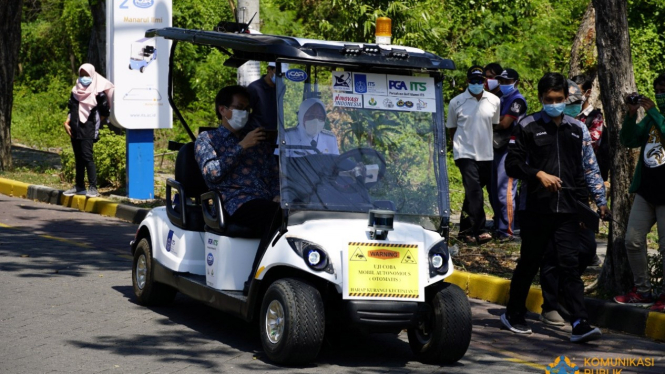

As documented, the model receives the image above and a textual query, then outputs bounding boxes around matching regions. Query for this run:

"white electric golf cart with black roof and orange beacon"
[131,23,471,364]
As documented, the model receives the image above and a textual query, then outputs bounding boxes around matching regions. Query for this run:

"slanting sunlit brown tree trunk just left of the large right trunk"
[568,1,603,110]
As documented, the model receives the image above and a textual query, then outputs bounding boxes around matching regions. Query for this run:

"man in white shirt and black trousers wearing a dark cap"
[446,65,501,244]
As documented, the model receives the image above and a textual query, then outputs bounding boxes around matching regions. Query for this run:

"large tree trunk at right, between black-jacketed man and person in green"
[593,0,637,294]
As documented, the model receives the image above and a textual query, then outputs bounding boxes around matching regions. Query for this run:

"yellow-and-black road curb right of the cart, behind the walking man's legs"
[446,271,665,341]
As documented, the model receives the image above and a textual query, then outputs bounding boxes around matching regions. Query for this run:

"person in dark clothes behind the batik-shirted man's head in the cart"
[247,62,277,130]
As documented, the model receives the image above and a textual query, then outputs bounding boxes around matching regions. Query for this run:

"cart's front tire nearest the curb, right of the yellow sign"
[408,283,472,364]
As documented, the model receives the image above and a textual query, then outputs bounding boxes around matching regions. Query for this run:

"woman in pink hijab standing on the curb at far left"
[63,64,114,197]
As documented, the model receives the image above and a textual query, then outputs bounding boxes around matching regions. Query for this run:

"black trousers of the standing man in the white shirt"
[455,158,492,237]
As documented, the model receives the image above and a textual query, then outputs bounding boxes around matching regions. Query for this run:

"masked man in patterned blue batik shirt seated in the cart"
[194,86,281,291]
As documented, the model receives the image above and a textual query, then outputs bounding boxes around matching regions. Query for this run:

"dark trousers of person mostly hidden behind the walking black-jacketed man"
[540,228,597,311]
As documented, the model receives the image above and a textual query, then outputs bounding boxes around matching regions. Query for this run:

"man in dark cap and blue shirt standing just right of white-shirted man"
[490,69,527,240]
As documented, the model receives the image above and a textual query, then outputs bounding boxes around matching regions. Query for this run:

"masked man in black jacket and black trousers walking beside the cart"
[501,73,601,342]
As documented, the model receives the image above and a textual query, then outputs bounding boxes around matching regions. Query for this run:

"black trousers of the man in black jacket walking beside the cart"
[506,211,588,323]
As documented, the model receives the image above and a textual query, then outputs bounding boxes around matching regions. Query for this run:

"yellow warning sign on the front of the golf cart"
[344,242,426,300]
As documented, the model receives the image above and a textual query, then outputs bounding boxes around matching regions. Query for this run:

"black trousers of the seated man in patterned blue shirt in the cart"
[230,199,282,282]
